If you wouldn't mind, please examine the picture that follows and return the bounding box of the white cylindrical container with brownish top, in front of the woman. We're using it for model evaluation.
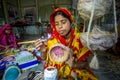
[44,66,57,80]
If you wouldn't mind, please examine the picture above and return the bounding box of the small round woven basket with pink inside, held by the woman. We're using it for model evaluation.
[49,44,69,62]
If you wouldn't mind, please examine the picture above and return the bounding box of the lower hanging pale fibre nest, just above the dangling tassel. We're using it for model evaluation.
[80,26,117,50]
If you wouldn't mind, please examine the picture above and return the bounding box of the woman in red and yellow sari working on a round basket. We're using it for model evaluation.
[35,8,97,80]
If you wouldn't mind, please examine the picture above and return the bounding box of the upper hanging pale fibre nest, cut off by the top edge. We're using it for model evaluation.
[77,0,112,20]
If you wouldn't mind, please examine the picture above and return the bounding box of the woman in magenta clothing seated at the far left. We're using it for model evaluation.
[0,24,18,50]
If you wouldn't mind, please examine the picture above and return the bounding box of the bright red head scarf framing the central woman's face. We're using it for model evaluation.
[50,8,74,45]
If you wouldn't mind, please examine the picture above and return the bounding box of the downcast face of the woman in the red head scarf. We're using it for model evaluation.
[54,15,71,36]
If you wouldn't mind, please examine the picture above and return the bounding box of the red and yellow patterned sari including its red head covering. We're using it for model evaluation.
[44,8,97,80]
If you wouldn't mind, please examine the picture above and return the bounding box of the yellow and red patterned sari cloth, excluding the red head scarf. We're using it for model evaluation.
[44,33,97,80]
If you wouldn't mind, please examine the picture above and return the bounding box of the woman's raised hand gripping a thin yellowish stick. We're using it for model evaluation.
[34,39,47,53]
